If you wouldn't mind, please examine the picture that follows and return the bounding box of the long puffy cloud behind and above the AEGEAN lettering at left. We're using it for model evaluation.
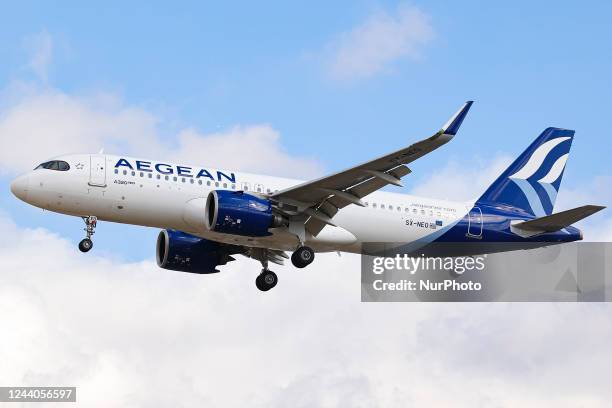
[0,88,322,178]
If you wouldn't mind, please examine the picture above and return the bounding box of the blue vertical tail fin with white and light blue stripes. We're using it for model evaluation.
[477,128,574,217]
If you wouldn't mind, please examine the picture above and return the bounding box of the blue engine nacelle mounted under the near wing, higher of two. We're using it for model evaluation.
[204,190,284,237]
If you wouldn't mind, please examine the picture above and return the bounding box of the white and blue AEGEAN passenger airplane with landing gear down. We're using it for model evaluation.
[11,101,605,291]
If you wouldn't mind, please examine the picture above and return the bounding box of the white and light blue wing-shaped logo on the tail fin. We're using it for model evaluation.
[509,137,571,217]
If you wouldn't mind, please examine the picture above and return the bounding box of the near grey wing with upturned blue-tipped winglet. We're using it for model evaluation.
[270,101,473,235]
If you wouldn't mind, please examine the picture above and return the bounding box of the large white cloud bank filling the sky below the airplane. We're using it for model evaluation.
[0,212,612,407]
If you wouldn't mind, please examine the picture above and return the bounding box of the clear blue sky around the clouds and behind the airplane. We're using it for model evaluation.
[0,1,612,259]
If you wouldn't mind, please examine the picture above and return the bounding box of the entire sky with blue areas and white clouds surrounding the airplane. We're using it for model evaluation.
[0,1,612,407]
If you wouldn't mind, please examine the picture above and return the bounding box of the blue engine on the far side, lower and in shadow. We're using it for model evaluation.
[155,230,240,273]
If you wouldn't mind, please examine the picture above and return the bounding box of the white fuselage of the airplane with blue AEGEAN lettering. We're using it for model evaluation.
[13,154,471,252]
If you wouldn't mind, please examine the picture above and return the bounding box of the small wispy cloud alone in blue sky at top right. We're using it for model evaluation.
[327,5,434,80]
